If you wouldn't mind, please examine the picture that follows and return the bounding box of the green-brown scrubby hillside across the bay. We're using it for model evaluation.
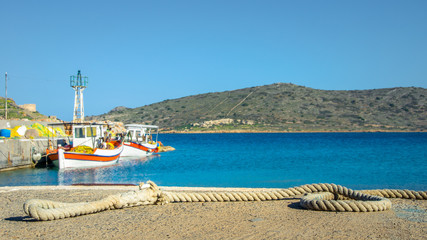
[88,83,427,131]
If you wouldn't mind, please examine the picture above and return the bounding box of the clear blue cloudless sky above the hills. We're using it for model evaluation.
[0,0,427,120]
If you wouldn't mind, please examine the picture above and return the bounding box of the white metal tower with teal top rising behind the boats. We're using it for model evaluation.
[70,70,88,122]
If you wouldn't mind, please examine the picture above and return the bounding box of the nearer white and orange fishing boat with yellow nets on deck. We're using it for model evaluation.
[47,123,123,169]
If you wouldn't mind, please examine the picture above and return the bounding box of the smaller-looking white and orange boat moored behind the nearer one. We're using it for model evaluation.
[120,124,161,158]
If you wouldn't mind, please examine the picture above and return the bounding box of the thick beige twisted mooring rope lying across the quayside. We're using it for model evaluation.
[24,181,427,220]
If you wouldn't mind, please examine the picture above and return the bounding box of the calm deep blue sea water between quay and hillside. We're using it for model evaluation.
[0,133,427,190]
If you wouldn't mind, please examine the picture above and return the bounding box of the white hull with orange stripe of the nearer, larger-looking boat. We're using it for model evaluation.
[49,145,123,169]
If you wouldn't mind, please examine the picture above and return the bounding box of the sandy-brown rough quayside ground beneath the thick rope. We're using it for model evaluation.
[0,186,427,239]
